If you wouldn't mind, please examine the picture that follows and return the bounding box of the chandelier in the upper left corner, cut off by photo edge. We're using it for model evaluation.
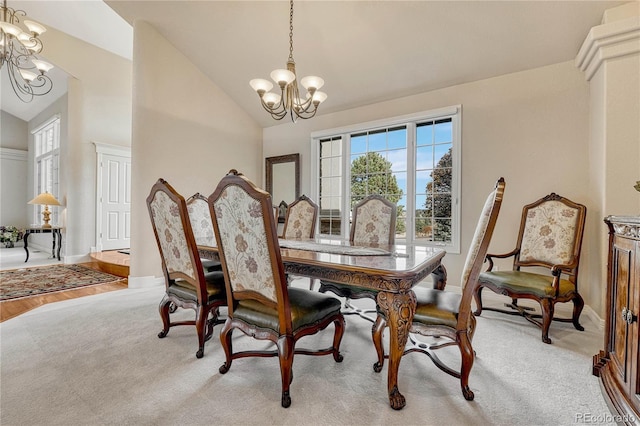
[0,0,53,102]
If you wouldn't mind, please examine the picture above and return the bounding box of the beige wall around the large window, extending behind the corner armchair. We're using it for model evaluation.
[263,61,602,312]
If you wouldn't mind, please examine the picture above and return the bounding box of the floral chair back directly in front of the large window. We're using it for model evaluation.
[350,195,396,246]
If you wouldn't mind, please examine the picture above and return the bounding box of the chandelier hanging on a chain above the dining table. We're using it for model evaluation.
[249,0,327,123]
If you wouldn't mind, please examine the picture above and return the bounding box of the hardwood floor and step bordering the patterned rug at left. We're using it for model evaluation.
[0,252,129,322]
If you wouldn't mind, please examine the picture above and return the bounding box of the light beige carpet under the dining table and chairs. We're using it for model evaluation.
[0,281,613,426]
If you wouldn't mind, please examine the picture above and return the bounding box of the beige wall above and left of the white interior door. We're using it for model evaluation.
[29,28,132,263]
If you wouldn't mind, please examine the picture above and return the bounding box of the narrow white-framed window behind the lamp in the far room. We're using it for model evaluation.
[32,115,60,225]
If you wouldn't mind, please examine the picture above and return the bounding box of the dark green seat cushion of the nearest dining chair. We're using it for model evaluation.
[233,287,342,332]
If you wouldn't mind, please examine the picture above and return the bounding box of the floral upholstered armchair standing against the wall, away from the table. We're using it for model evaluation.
[475,193,587,343]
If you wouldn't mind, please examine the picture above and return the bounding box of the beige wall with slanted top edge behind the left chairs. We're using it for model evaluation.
[129,22,263,286]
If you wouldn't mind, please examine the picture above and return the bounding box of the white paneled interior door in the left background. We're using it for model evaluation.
[97,143,131,251]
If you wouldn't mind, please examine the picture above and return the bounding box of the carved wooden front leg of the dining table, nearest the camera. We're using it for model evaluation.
[377,290,416,410]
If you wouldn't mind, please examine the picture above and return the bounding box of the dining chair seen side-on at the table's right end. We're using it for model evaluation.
[372,178,505,401]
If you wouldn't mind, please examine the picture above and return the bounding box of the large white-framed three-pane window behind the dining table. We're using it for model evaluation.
[311,105,461,253]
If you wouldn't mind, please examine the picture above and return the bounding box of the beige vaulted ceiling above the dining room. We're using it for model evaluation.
[3,0,624,127]
